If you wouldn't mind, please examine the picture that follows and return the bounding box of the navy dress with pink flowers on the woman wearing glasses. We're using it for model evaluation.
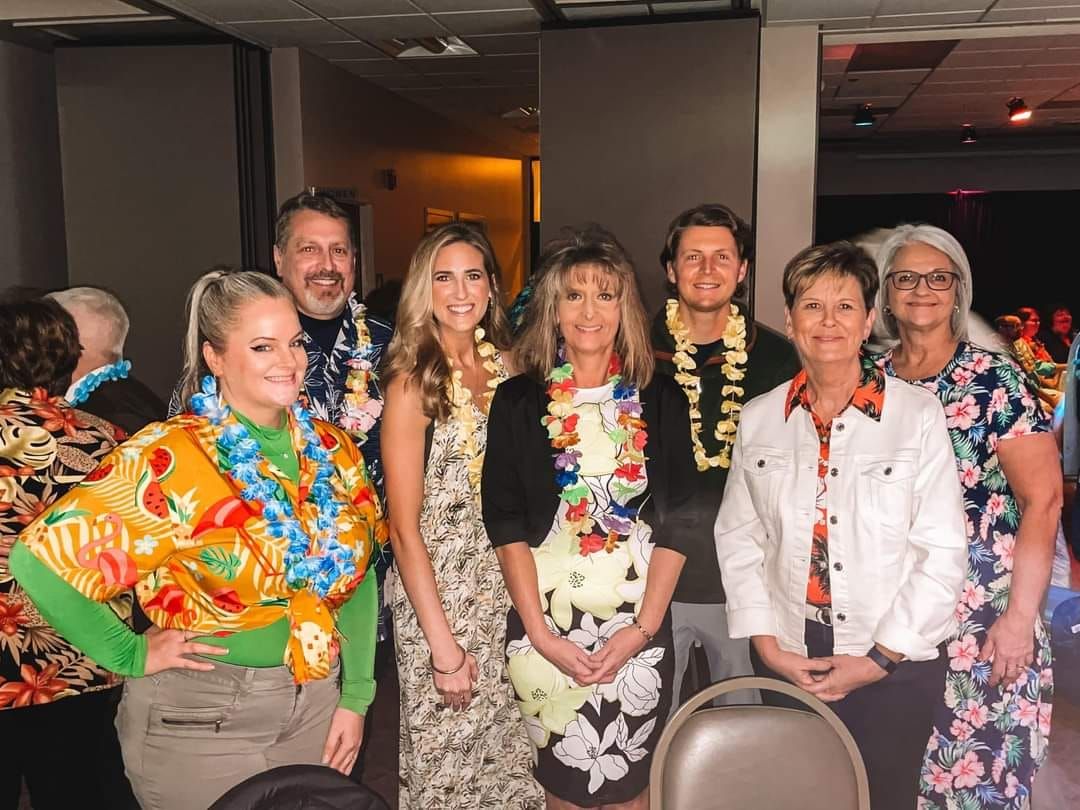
[881,341,1054,810]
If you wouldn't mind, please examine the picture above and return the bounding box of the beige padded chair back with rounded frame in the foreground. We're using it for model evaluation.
[649,677,870,810]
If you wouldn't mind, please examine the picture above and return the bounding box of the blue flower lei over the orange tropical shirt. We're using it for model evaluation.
[191,377,356,599]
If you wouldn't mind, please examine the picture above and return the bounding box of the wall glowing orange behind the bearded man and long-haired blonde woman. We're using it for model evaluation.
[293,52,527,302]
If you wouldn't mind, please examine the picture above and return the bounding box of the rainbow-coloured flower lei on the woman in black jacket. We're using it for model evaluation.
[540,354,648,556]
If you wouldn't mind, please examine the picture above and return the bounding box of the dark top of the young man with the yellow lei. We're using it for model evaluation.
[652,309,799,604]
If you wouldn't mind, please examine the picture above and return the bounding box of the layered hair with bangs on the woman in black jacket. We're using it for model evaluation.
[515,225,656,388]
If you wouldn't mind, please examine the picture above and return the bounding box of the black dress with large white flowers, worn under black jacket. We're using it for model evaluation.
[507,384,675,807]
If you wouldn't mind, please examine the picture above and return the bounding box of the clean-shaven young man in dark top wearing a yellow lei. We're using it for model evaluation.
[650,204,799,712]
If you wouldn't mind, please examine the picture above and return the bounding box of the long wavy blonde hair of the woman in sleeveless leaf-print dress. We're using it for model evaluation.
[382,222,510,421]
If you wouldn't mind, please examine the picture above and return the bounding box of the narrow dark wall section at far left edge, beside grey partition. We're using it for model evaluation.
[0,42,67,289]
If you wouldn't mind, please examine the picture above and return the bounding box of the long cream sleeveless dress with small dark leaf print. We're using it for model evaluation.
[392,382,543,810]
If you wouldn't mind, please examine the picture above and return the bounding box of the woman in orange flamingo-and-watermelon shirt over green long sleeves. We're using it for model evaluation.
[11,271,386,810]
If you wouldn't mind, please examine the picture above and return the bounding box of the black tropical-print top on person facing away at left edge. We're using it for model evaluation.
[0,389,131,708]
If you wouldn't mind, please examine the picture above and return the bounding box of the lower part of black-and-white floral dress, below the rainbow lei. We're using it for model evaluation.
[507,524,675,807]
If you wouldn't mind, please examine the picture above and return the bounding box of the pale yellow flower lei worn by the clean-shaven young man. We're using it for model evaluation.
[664,298,746,472]
